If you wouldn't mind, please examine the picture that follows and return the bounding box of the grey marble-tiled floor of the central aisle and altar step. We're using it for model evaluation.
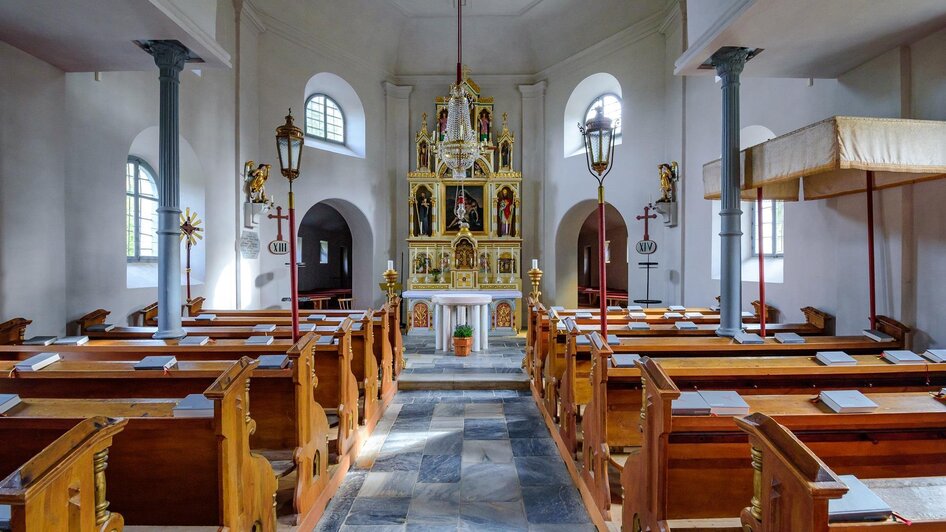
[316,338,594,532]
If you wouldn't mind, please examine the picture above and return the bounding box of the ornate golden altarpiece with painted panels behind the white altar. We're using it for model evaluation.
[404,77,522,334]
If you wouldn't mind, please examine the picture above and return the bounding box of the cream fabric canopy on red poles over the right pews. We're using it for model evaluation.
[703,116,946,200]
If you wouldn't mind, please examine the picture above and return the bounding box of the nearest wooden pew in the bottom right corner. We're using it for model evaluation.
[734,413,946,532]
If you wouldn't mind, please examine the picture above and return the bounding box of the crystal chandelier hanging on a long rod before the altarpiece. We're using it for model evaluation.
[438,0,480,179]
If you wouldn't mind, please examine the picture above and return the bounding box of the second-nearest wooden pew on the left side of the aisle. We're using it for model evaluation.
[4,358,276,531]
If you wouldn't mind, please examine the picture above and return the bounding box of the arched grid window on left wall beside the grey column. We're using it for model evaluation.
[125,157,158,262]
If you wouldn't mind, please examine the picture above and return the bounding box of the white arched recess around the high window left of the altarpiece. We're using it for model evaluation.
[299,72,365,159]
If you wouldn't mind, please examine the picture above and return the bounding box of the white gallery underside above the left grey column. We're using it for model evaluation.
[0,0,230,72]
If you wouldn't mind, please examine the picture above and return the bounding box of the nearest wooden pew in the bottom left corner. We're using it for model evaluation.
[0,416,127,532]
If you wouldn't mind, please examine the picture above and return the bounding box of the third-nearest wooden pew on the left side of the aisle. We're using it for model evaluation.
[0,334,340,526]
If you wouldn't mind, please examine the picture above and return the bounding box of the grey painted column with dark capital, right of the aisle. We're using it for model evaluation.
[711,48,749,336]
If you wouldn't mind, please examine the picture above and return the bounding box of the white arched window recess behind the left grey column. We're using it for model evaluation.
[121,126,207,288]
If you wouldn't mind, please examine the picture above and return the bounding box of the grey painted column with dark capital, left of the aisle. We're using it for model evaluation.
[149,41,190,338]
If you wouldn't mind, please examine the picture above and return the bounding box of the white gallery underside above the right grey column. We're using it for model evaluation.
[676,0,946,78]
